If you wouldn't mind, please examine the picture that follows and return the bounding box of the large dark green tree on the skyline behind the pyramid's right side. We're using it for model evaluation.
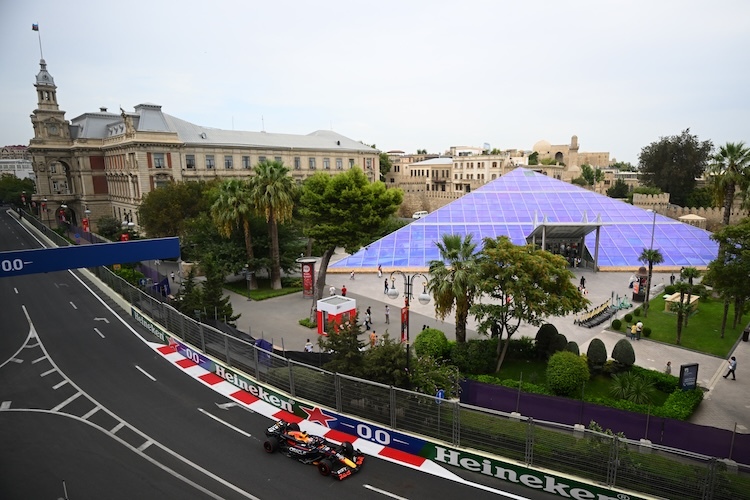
[638,129,713,206]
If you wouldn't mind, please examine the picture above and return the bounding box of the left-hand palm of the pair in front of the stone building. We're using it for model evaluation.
[211,179,258,290]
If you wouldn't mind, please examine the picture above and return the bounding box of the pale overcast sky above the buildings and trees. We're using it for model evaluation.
[0,0,750,163]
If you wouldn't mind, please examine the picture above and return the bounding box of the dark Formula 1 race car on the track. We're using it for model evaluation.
[263,420,365,481]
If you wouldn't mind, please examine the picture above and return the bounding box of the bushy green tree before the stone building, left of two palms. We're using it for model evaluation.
[138,181,215,238]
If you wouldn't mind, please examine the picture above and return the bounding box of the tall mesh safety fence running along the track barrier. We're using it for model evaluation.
[19,212,750,500]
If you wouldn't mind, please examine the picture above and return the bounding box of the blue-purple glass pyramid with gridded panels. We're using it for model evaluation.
[331,168,718,271]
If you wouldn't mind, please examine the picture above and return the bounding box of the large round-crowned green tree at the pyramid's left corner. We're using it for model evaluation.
[300,168,403,304]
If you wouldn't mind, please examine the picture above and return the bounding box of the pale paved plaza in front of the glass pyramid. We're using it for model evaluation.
[201,255,750,433]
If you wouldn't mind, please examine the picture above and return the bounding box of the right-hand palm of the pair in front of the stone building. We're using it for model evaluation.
[250,160,295,290]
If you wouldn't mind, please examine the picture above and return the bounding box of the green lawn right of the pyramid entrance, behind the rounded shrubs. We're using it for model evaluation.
[620,295,747,358]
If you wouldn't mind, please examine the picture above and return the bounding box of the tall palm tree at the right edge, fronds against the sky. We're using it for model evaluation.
[708,142,750,226]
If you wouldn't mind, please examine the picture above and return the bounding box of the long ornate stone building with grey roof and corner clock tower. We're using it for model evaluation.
[28,59,380,230]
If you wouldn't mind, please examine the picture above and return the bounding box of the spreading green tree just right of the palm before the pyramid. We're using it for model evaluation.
[471,236,589,371]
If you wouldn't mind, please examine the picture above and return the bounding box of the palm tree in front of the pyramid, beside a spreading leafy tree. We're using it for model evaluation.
[427,234,477,342]
